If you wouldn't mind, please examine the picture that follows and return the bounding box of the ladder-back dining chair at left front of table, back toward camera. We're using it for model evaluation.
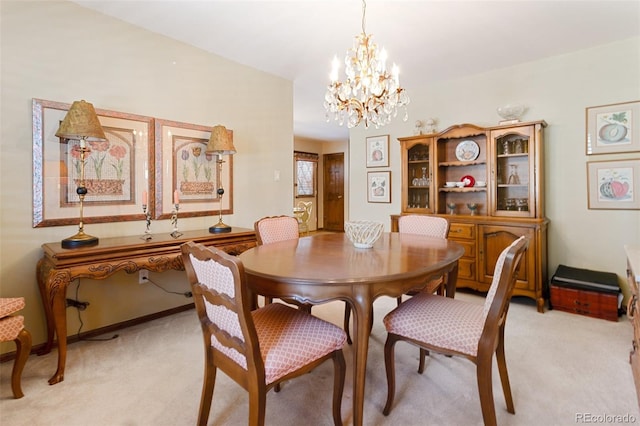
[181,242,347,426]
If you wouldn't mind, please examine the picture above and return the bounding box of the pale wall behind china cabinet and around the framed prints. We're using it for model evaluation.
[349,38,640,300]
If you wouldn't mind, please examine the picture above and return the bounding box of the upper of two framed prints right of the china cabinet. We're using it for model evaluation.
[586,101,640,155]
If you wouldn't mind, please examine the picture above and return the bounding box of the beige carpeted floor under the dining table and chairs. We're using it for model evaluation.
[0,292,640,426]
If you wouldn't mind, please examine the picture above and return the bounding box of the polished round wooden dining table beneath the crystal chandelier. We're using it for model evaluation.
[239,232,464,426]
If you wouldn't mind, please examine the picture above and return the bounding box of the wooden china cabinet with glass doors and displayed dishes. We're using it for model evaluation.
[391,121,548,312]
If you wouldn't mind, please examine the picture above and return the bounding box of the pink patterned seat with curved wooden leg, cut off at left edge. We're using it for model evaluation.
[0,297,31,399]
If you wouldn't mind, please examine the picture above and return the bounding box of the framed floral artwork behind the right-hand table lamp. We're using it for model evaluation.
[155,119,233,219]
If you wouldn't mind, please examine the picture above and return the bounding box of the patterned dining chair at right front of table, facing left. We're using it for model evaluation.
[382,236,529,426]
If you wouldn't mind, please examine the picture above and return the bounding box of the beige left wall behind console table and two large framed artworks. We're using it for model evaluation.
[0,0,293,352]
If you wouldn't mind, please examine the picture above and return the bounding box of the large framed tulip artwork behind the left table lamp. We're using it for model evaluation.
[32,99,154,228]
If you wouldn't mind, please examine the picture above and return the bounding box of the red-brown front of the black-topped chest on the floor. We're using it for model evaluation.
[550,284,618,321]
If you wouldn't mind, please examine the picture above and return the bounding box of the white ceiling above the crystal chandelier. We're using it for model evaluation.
[74,0,640,141]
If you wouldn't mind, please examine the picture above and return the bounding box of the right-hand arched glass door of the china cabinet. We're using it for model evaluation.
[491,126,536,217]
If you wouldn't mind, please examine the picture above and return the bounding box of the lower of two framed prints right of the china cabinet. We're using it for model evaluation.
[587,159,640,210]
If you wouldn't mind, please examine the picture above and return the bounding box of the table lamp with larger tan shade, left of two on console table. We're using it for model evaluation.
[56,100,107,248]
